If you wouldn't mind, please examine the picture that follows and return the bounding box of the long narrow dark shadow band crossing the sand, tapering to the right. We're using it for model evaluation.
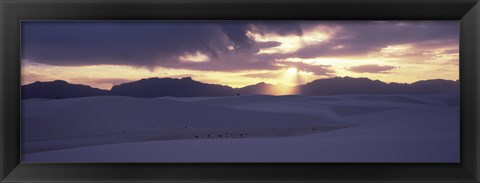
[22,125,351,154]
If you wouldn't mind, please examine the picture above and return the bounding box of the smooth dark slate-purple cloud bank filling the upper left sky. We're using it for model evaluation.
[22,22,228,66]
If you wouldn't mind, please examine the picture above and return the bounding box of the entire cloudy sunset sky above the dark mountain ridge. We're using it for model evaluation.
[21,21,459,89]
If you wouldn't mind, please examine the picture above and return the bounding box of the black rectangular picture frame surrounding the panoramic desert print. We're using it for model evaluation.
[0,0,480,182]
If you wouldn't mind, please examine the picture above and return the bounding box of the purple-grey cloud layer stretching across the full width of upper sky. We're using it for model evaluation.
[22,21,459,71]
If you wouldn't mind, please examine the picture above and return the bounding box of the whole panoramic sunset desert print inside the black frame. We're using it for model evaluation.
[21,21,460,163]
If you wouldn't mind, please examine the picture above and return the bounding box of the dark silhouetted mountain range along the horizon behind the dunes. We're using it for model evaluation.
[22,77,460,99]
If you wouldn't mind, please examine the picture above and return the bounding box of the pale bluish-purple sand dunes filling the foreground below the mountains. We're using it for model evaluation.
[22,94,459,162]
